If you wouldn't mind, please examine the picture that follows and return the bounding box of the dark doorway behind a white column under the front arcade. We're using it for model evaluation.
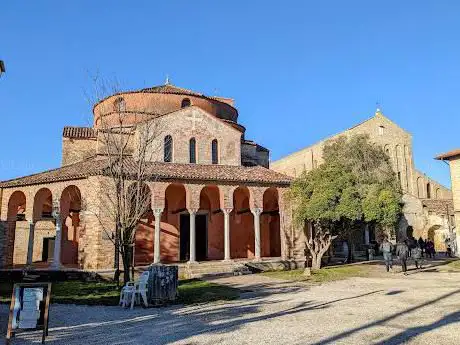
[179,214,208,261]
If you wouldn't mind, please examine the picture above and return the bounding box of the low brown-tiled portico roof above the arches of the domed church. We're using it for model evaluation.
[0,157,292,188]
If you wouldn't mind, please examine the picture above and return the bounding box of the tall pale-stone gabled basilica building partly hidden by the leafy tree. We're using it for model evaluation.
[270,109,455,251]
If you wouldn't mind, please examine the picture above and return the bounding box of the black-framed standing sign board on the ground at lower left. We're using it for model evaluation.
[6,283,51,345]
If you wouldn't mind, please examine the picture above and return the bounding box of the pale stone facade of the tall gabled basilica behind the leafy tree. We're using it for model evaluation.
[270,110,452,250]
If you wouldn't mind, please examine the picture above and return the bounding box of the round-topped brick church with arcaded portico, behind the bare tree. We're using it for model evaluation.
[0,82,304,270]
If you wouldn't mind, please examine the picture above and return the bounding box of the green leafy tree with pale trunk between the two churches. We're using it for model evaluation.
[290,135,402,269]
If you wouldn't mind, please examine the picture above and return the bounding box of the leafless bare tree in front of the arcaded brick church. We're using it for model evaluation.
[85,78,161,283]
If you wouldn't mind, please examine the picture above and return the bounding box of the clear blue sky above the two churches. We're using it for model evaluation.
[0,0,460,185]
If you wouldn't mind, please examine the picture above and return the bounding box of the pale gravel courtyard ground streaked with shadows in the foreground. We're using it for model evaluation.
[0,269,460,345]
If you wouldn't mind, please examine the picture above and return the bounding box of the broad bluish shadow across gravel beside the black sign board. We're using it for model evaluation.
[0,290,382,345]
